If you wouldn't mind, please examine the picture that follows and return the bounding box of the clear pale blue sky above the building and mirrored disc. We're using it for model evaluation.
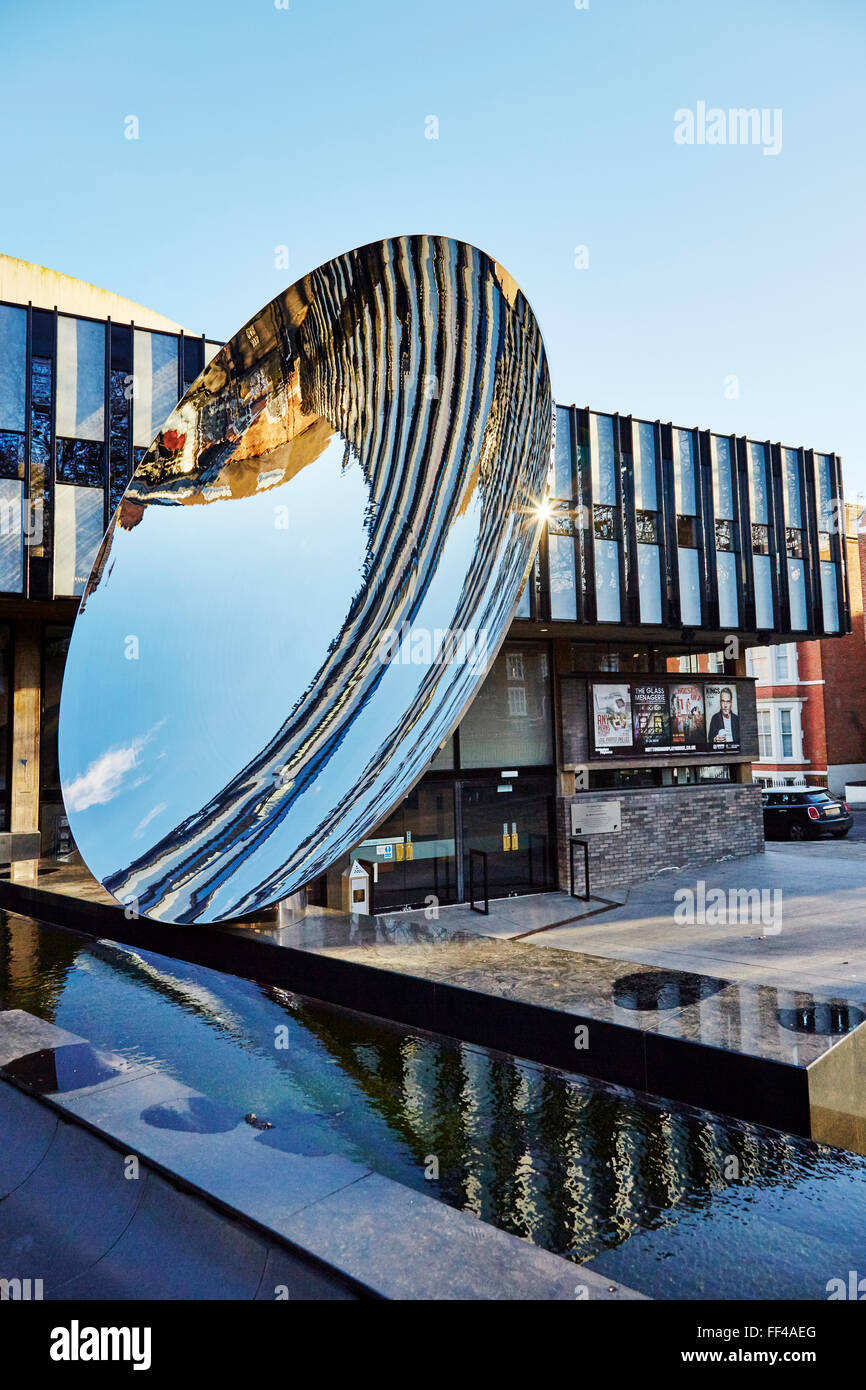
[0,0,866,496]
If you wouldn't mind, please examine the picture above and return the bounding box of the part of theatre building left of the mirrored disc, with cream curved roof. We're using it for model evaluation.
[0,256,218,855]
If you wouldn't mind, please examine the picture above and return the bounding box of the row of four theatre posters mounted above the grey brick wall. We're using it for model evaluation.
[589,676,741,758]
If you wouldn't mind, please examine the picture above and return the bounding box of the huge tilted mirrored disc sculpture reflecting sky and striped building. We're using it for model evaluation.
[60,236,552,923]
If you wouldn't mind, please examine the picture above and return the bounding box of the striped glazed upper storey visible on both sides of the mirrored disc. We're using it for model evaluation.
[0,283,849,646]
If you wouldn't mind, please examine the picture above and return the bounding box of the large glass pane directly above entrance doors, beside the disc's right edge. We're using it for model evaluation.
[460,642,553,767]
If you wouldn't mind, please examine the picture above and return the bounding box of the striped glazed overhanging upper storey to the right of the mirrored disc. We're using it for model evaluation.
[518,406,851,645]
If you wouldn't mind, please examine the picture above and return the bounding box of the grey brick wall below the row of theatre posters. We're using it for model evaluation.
[556,784,763,892]
